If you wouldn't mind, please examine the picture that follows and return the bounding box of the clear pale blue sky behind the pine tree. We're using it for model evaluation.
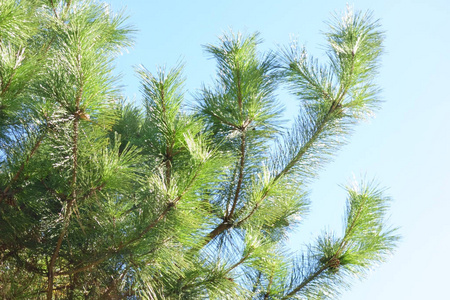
[105,0,450,300]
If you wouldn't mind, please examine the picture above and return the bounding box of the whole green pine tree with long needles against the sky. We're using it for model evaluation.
[0,0,398,299]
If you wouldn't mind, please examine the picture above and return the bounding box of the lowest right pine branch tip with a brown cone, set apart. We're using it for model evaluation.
[282,179,398,299]
